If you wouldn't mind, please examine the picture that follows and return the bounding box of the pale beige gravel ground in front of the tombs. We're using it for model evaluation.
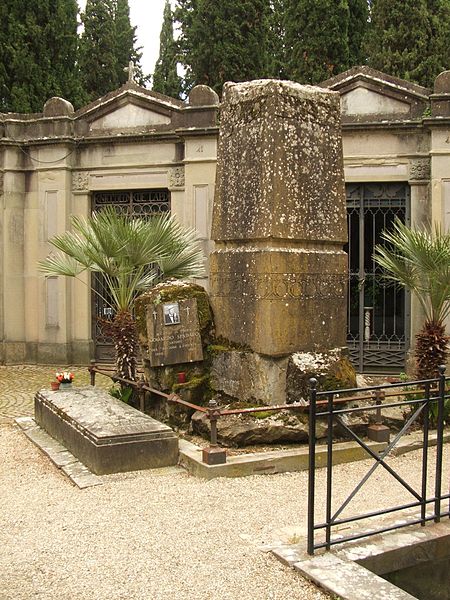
[0,425,449,600]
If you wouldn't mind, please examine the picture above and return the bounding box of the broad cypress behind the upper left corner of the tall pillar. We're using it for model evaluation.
[184,0,269,94]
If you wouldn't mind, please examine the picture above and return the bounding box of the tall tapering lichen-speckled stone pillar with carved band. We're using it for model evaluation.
[210,80,354,403]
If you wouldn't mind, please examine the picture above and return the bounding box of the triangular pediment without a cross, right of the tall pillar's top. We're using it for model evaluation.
[321,66,431,121]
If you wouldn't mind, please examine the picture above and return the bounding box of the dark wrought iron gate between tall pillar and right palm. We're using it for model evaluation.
[346,183,410,373]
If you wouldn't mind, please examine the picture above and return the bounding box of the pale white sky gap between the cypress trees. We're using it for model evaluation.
[78,0,174,75]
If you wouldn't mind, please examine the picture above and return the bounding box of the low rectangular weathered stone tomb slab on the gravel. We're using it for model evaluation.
[34,386,178,475]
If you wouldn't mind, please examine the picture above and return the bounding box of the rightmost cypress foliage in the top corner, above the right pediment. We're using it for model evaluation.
[366,0,450,86]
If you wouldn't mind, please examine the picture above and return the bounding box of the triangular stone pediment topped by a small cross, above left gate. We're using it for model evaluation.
[77,83,184,134]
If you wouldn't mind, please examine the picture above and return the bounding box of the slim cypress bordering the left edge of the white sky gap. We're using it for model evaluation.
[115,0,147,85]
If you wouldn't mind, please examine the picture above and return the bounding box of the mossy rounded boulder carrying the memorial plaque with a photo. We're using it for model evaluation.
[136,280,213,418]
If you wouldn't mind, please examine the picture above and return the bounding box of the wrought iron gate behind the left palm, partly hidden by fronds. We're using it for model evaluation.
[92,190,170,362]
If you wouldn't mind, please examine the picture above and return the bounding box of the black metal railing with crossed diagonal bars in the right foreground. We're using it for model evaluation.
[307,367,450,554]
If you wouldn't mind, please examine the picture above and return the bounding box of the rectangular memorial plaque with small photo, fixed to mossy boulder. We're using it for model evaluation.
[147,298,203,367]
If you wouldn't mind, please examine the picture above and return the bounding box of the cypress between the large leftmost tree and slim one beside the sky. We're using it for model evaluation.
[80,0,119,100]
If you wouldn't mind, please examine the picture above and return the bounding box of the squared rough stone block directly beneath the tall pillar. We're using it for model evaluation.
[211,350,288,404]
